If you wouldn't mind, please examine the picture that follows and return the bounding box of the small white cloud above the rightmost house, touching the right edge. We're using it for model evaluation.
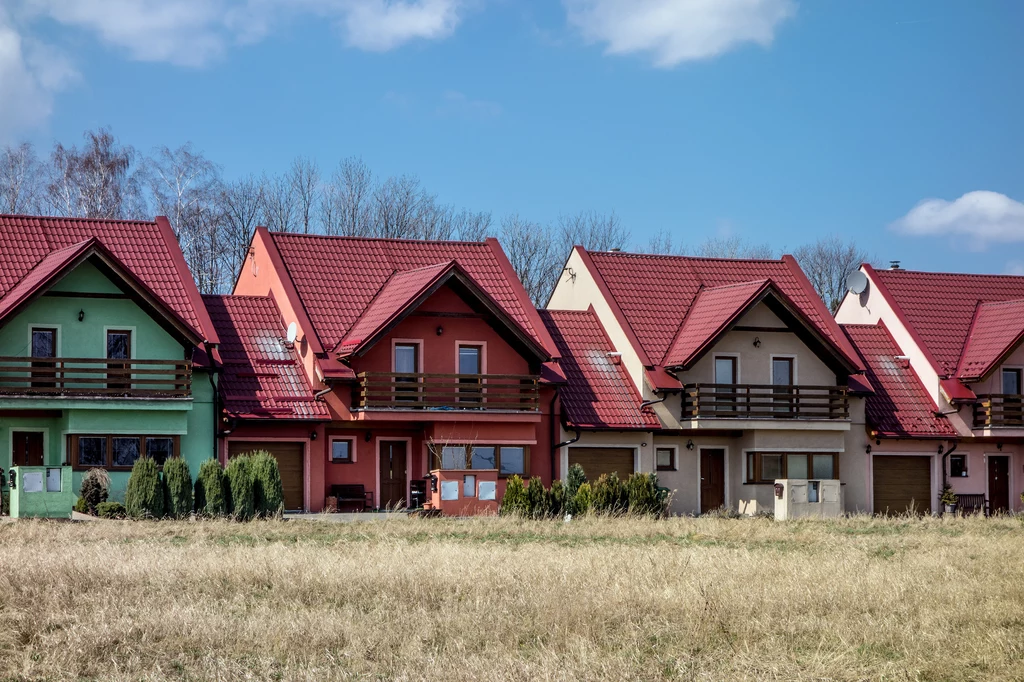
[892,190,1024,250]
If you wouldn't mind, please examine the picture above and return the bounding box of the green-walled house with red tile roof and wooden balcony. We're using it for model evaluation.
[0,216,218,501]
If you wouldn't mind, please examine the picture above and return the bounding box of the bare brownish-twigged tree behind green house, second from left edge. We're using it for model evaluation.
[47,128,142,218]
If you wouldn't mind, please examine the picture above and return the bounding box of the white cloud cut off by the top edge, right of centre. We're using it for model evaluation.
[563,0,796,68]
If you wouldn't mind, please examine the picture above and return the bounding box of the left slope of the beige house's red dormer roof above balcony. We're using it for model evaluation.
[660,280,770,367]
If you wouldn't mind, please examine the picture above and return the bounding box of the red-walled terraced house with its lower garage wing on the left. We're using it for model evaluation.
[220,228,563,513]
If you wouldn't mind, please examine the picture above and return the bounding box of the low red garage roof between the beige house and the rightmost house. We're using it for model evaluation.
[843,323,956,438]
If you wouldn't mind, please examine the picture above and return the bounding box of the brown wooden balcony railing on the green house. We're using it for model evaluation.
[0,357,191,397]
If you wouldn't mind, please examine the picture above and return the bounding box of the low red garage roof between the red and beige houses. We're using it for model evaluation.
[540,310,660,430]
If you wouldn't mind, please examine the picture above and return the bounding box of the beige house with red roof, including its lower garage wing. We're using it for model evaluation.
[545,247,866,514]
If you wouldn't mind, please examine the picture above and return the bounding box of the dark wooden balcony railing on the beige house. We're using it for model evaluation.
[683,384,850,420]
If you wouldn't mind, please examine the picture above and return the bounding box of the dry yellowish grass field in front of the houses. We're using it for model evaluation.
[0,518,1024,680]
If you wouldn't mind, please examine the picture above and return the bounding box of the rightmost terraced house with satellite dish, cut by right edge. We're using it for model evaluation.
[836,265,1024,513]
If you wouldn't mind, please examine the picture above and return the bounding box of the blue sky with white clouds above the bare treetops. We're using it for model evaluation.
[0,0,1024,273]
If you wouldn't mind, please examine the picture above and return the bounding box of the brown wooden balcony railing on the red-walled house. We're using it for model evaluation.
[353,372,540,412]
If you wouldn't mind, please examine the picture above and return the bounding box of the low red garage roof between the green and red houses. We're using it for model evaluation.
[203,296,331,420]
